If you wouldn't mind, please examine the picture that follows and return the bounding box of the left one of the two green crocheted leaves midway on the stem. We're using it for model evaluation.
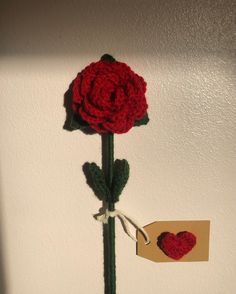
[84,162,111,201]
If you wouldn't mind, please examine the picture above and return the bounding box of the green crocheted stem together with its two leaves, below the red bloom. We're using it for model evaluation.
[84,133,129,294]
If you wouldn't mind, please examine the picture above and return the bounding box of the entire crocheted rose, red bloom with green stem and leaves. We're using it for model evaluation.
[68,54,149,294]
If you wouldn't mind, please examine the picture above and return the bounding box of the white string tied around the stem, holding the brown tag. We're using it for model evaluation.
[95,209,150,245]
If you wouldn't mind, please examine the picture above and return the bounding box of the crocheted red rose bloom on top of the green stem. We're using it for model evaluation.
[72,55,149,134]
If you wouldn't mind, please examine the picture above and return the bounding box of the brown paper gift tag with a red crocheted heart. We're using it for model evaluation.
[136,220,210,262]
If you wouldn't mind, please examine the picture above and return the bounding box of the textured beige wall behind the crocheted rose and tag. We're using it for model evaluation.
[0,0,236,294]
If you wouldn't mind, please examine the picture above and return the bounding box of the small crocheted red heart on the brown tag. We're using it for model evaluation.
[157,231,197,260]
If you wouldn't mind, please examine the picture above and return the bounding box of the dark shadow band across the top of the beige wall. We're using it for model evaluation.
[0,0,236,57]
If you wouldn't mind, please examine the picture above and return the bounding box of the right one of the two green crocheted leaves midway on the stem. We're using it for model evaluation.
[112,159,129,202]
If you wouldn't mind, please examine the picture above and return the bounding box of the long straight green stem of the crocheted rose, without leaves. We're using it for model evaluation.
[102,133,116,294]
